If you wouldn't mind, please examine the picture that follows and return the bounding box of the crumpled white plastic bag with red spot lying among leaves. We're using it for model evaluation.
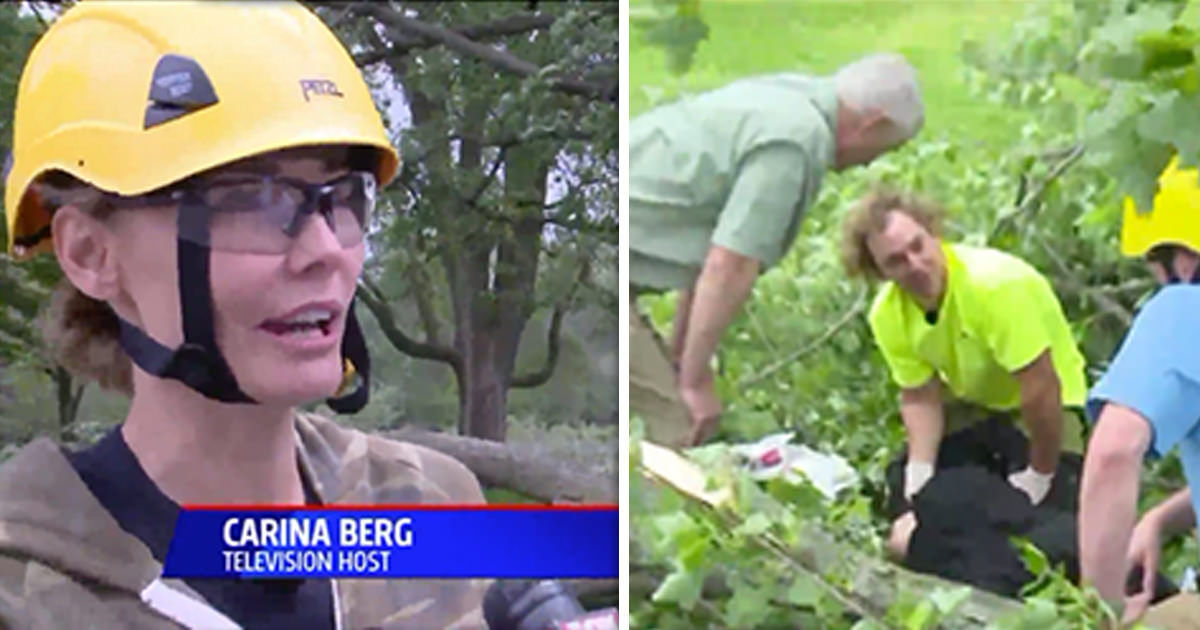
[732,433,858,499]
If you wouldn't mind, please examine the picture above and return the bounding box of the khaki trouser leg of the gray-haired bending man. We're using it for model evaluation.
[629,300,691,449]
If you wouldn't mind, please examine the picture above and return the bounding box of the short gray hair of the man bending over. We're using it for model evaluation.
[834,53,925,140]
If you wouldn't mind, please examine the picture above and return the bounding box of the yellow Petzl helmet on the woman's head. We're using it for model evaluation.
[5,0,400,259]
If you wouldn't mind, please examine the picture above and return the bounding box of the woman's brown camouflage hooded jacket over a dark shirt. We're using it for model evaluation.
[0,414,490,630]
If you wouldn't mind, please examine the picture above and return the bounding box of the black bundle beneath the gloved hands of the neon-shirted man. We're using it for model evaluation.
[888,420,1177,601]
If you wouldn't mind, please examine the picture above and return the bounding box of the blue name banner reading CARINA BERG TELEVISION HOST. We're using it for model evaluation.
[163,505,619,580]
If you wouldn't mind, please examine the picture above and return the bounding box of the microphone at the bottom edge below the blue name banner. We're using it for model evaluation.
[484,580,618,630]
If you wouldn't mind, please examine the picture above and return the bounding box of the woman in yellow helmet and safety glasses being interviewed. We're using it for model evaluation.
[0,1,486,630]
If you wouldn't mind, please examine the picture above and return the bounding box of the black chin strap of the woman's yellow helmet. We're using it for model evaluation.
[118,196,371,414]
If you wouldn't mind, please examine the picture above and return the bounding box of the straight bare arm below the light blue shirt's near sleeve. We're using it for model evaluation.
[1079,403,1151,605]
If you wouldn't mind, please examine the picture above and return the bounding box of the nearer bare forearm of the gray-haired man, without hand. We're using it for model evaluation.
[679,245,758,389]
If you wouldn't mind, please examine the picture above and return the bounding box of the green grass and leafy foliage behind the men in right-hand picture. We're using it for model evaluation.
[630,0,1200,628]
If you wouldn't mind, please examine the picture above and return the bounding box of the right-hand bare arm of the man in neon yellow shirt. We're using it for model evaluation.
[1013,349,1062,474]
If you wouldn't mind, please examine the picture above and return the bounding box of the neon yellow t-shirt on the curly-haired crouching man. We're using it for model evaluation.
[868,244,1087,450]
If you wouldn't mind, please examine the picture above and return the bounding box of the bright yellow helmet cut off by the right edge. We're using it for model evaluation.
[1121,156,1200,257]
